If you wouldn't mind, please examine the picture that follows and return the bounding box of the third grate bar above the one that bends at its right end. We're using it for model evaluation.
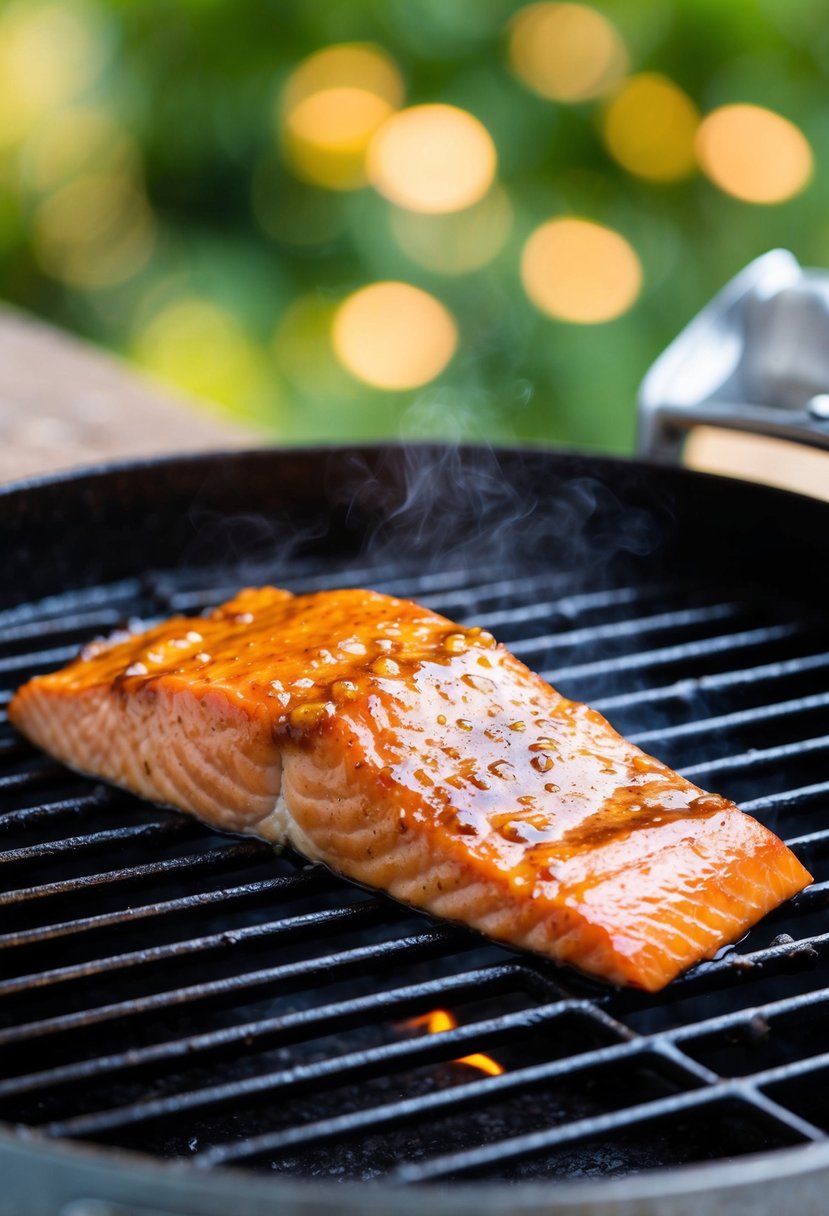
[0,867,331,950]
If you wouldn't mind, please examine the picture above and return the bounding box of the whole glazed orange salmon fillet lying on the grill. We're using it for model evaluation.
[9,587,811,991]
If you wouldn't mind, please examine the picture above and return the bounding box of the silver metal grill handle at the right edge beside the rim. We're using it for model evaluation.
[638,249,829,463]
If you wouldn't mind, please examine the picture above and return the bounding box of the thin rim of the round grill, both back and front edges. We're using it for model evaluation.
[0,443,829,1216]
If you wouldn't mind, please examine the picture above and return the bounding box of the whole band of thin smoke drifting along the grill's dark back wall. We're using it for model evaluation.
[162,445,670,637]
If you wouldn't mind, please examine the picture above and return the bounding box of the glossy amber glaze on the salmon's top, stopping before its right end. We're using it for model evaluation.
[68,587,731,895]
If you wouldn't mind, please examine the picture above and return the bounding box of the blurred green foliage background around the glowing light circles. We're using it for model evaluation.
[0,0,829,451]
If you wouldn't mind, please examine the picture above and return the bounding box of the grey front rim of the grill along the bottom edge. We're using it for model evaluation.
[8,1124,829,1216]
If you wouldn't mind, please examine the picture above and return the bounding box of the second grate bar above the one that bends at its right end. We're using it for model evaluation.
[0,899,389,997]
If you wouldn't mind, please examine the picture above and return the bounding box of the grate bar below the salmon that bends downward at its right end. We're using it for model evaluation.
[0,962,534,1098]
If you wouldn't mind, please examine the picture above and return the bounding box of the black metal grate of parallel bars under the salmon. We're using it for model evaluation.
[0,561,829,1183]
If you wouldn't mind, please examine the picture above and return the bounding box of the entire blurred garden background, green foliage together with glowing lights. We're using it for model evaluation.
[0,0,829,451]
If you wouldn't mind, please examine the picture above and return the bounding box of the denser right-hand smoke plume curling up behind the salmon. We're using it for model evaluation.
[329,444,662,585]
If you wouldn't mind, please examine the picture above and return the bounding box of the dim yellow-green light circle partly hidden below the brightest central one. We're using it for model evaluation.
[390,184,513,275]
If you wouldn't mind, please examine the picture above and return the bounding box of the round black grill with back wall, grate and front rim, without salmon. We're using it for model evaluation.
[0,447,829,1212]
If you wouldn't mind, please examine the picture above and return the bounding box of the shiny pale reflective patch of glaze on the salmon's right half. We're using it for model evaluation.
[349,641,733,901]
